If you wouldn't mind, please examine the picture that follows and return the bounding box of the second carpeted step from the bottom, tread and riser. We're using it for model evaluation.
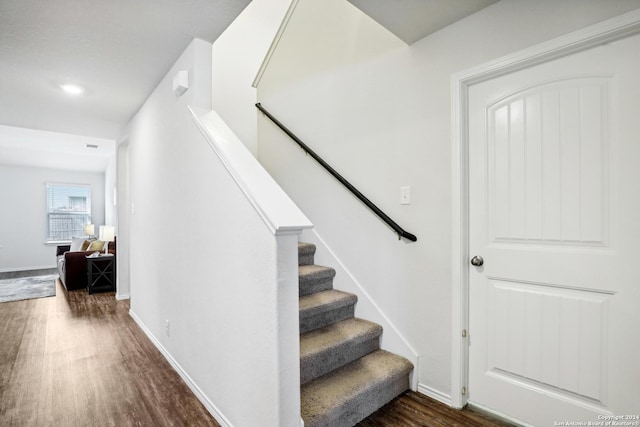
[300,318,382,384]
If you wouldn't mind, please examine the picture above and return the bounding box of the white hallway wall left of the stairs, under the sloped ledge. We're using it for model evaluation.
[127,40,300,427]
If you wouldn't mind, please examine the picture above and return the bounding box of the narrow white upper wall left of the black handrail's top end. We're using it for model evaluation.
[212,0,291,156]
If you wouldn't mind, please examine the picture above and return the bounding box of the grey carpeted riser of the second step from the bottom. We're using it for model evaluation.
[300,336,380,384]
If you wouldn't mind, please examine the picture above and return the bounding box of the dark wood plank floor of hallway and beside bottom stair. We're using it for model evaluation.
[0,276,507,427]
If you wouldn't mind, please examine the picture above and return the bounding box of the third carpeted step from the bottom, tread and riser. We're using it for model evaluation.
[298,289,358,334]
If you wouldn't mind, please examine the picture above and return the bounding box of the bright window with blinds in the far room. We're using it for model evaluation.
[47,184,91,242]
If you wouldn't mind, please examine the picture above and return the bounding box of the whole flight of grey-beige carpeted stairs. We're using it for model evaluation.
[298,243,413,427]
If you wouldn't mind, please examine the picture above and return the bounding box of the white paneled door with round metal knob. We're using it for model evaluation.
[469,32,640,426]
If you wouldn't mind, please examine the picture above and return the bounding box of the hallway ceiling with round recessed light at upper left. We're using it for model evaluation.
[0,0,250,174]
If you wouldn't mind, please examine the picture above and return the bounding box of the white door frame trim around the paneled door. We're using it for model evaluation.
[451,9,640,408]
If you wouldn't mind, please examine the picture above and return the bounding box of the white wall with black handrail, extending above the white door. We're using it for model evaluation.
[258,0,640,401]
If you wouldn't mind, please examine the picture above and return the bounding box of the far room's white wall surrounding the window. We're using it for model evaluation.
[0,165,105,271]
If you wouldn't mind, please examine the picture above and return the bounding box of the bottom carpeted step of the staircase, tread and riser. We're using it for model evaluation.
[301,350,413,427]
